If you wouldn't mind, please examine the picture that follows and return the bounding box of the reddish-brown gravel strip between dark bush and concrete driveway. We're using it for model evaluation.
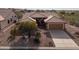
[39,29,55,47]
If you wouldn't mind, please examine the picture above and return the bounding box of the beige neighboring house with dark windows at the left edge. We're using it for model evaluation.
[0,9,18,30]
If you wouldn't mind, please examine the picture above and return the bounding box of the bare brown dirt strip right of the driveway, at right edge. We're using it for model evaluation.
[66,24,79,46]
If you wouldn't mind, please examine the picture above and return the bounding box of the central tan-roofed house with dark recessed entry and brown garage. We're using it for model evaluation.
[23,12,66,30]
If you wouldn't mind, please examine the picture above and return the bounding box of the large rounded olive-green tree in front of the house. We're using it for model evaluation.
[19,21,37,38]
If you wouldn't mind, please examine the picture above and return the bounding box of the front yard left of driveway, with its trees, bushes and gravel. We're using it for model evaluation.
[7,22,55,48]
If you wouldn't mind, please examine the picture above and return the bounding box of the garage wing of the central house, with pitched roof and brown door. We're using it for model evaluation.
[44,16,66,30]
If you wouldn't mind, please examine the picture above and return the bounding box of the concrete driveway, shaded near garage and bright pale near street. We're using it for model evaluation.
[50,30,78,48]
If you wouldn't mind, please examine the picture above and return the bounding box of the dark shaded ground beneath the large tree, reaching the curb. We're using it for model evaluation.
[10,37,39,50]
